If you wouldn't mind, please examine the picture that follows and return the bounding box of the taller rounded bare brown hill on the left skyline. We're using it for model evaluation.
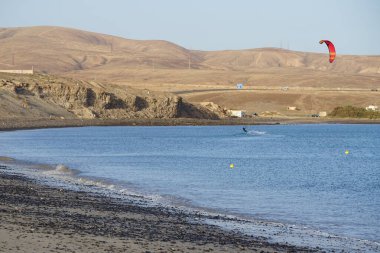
[0,27,197,73]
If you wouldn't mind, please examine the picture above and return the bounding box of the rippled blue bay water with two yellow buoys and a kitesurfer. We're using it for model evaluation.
[0,124,380,251]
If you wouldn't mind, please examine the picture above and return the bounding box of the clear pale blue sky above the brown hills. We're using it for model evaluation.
[0,0,380,55]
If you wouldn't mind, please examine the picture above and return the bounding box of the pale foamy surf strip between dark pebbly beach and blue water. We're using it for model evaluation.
[0,158,380,252]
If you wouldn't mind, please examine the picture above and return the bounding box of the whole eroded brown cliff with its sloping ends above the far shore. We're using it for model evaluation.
[0,75,226,119]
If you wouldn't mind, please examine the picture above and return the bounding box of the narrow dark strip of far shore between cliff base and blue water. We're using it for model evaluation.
[0,117,380,131]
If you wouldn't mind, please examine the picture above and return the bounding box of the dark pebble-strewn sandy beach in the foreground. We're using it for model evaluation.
[0,163,315,252]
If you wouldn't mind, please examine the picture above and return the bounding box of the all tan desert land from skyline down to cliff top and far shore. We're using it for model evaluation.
[0,27,380,115]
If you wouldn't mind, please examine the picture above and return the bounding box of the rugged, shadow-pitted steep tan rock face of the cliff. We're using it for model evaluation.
[35,84,182,118]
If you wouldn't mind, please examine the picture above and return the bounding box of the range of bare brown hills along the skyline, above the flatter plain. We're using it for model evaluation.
[0,26,380,74]
